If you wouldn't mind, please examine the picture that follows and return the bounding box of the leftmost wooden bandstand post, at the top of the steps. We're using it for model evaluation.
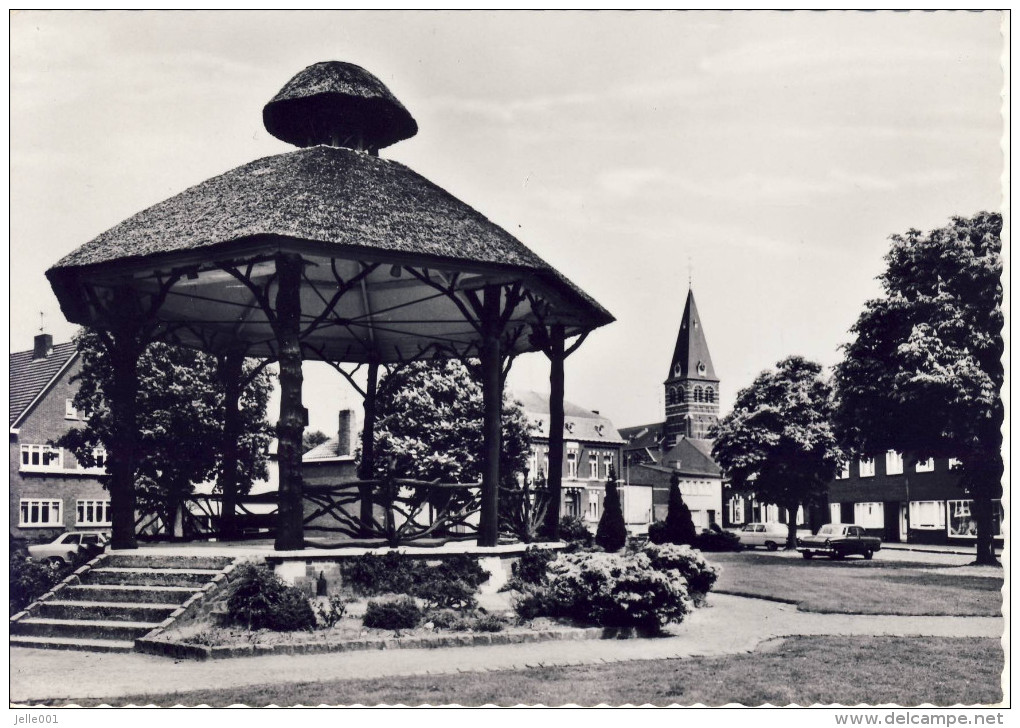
[106,329,144,549]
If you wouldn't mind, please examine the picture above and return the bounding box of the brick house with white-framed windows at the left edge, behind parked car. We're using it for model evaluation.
[8,333,110,540]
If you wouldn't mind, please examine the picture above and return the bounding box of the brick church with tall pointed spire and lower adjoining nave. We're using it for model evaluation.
[620,290,723,528]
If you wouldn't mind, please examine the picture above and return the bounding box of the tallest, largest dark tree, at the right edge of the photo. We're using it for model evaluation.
[834,212,1004,564]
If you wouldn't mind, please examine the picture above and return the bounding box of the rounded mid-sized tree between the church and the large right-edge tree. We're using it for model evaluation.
[712,356,843,549]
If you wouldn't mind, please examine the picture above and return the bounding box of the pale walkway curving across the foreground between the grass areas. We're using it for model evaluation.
[10,594,1004,705]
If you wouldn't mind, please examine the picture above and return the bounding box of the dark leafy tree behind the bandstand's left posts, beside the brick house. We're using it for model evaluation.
[57,329,271,530]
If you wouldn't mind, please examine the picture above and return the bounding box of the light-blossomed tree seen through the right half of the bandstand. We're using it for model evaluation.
[374,359,531,487]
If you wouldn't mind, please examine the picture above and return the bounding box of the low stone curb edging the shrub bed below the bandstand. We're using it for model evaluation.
[135,627,605,660]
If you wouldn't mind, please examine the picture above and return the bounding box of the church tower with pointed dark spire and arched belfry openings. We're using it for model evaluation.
[665,290,719,448]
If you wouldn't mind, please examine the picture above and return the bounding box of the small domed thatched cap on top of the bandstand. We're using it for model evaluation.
[262,61,418,150]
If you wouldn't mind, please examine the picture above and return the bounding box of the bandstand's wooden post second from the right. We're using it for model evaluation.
[478,285,503,547]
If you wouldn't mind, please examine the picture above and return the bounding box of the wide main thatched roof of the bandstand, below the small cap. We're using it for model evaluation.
[47,147,613,361]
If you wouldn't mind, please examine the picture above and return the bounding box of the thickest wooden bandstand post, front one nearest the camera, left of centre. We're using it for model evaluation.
[275,253,305,551]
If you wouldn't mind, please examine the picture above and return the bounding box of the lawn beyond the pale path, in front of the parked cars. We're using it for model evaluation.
[708,552,1003,617]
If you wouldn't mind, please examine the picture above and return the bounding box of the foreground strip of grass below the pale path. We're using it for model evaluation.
[47,637,1004,707]
